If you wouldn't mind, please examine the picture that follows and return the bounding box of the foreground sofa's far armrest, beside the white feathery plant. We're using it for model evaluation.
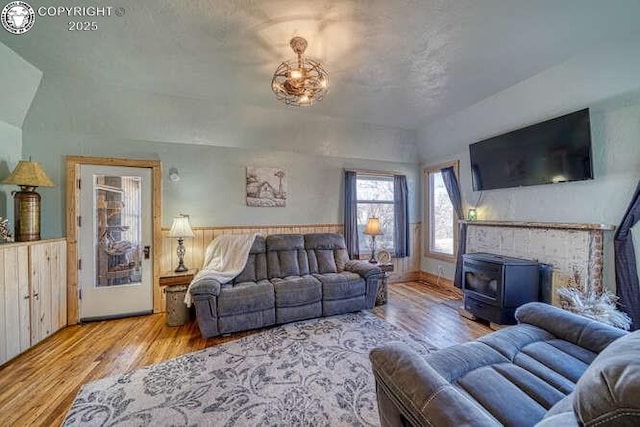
[516,302,627,353]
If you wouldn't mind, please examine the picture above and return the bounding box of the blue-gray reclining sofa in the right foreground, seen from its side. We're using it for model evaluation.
[370,303,640,427]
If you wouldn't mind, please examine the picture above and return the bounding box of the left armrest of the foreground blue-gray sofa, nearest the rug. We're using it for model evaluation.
[369,343,500,426]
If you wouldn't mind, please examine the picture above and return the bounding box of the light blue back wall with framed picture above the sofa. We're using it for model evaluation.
[23,75,419,237]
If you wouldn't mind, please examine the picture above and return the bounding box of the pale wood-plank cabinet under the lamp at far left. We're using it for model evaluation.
[0,239,67,364]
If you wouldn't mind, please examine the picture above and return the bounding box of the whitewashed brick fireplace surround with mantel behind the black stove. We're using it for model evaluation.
[463,221,615,305]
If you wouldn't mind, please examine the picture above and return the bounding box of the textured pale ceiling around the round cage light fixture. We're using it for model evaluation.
[0,0,640,129]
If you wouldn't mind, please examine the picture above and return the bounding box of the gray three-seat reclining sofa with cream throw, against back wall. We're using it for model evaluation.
[191,233,381,338]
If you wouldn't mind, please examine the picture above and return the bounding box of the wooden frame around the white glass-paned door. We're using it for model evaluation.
[66,156,163,325]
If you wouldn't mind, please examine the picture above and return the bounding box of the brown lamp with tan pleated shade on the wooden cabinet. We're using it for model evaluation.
[2,159,55,242]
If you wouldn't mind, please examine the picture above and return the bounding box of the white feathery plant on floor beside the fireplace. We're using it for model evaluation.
[558,272,631,330]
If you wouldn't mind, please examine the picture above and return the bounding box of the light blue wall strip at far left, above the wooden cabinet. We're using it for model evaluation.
[0,43,42,224]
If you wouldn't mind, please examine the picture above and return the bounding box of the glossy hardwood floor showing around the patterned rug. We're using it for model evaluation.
[0,282,491,426]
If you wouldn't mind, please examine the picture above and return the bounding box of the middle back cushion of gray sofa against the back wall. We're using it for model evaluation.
[266,234,309,279]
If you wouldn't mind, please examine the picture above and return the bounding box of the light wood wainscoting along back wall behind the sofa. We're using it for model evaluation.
[160,223,420,309]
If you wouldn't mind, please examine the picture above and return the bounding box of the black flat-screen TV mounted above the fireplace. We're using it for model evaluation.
[469,108,593,191]
